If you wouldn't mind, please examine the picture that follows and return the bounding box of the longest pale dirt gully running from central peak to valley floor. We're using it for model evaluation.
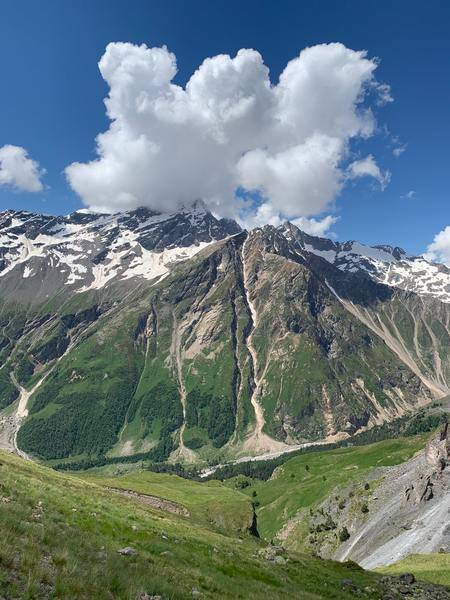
[242,237,288,452]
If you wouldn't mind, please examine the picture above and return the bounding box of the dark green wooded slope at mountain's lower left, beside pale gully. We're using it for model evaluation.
[18,310,142,459]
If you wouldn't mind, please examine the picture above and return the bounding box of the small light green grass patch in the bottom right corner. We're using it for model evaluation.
[377,554,450,586]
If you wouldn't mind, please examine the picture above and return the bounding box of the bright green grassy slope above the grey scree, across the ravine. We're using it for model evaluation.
[234,434,430,547]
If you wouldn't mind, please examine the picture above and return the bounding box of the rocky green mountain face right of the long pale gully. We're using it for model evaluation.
[243,254,436,439]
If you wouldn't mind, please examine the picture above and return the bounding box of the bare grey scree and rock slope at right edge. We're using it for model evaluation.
[324,425,450,569]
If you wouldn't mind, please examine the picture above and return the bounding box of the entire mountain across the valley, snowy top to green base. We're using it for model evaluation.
[0,205,450,462]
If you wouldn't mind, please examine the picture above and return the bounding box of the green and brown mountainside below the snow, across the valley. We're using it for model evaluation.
[0,233,450,468]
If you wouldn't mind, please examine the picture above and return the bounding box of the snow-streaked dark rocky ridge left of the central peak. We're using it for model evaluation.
[0,206,240,296]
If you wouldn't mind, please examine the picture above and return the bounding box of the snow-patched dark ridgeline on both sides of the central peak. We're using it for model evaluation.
[0,201,450,302]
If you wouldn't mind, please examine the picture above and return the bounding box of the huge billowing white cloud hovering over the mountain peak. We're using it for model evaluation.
[66,43,390,223]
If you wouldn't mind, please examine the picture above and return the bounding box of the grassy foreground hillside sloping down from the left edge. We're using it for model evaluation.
[0,452,390,600]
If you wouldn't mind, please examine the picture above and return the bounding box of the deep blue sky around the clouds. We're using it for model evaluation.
[0,0,450,253]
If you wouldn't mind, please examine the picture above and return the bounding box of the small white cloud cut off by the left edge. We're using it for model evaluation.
[0,144,45,192]
